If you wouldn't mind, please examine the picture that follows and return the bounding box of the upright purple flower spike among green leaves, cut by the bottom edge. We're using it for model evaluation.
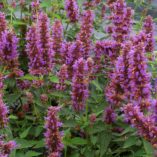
[45,106,63,157]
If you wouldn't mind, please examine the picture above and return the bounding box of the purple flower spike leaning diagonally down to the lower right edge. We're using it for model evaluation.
[123,104,157,146]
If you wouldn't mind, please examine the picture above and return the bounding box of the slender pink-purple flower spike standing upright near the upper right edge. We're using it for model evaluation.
[143,16,155,52]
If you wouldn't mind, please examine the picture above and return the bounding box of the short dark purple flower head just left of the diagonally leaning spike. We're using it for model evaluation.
[103,106,117,124]
